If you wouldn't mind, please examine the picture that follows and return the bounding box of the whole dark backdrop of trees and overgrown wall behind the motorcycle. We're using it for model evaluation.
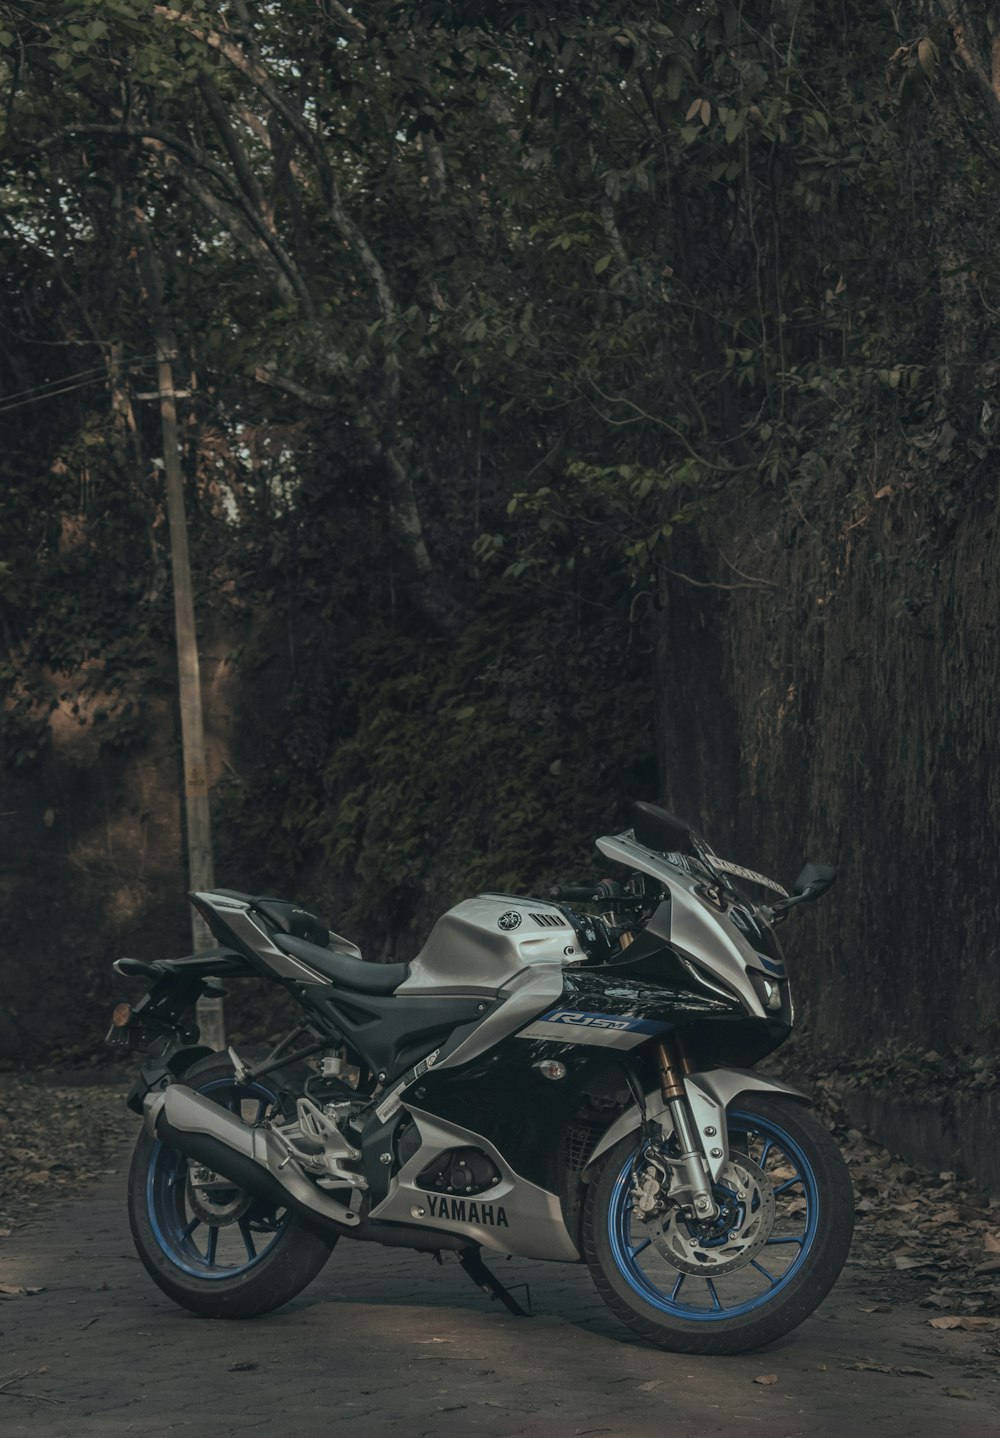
[0,0,1000,1063]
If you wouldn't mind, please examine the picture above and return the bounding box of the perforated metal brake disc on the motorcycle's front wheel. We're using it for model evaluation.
[649,1153,774,1278]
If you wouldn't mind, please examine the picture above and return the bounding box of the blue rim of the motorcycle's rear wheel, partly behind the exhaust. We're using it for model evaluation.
[145,1079,289,1281]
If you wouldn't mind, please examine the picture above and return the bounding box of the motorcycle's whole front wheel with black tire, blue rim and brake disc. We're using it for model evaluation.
[583,1094,853,1353]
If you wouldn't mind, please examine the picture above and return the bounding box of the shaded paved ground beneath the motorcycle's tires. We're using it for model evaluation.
[0,1104,1000,1438]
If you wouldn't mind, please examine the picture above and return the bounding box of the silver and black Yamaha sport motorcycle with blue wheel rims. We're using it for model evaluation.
[108,802,853,1355]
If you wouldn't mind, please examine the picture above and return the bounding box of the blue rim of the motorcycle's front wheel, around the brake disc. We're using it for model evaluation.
[607,1112,820,1323]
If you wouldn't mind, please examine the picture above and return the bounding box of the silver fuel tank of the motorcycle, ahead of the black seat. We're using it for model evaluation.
[396,893,587,994]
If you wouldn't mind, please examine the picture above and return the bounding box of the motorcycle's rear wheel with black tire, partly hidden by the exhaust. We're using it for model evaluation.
[128,1054,337,1319]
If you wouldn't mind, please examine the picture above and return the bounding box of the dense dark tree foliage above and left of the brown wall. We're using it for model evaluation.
[0,0,997,977]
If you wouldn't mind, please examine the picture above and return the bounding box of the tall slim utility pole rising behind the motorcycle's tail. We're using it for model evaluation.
[135,227,226,1048]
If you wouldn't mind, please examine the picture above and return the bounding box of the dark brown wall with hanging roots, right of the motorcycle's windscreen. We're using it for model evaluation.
[660,454,1000,1063]
